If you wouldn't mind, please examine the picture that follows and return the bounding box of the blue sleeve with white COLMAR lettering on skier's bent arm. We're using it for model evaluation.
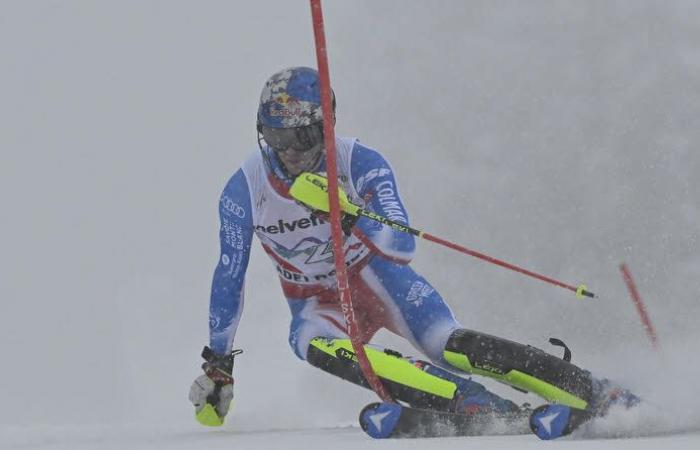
[350,142,416,264]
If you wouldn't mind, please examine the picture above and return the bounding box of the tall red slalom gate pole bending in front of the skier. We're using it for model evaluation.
[310,0,393,402]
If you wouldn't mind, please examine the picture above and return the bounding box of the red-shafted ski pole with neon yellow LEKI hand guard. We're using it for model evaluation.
[289,172,596,298]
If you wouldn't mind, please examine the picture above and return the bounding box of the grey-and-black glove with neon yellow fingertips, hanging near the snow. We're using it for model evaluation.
[189,347,243,426]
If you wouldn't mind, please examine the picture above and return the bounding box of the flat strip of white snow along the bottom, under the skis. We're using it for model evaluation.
[0,425,700,450]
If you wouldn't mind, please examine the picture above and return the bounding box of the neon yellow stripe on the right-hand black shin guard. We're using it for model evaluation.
[443,350,588,409]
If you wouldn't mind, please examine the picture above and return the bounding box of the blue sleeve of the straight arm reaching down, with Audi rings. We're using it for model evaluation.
[209,170,253,354]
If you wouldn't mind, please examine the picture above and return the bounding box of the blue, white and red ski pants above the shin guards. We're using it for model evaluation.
[287,256,462,365]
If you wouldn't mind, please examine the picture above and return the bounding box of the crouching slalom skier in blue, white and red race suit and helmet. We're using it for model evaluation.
[190,67,636,434]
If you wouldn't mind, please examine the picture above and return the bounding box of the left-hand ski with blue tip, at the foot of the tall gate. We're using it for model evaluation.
[360,402,530,439]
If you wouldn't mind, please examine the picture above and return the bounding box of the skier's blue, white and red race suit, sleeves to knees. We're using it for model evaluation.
[209,138,461,362]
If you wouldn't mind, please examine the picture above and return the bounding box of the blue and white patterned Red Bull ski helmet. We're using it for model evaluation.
[257,67,335,131]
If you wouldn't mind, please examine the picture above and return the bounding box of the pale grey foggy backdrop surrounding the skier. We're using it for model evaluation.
[0,0,700,438]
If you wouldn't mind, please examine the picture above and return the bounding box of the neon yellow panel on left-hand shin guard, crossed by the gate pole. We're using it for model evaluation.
[310,338,457,399]
